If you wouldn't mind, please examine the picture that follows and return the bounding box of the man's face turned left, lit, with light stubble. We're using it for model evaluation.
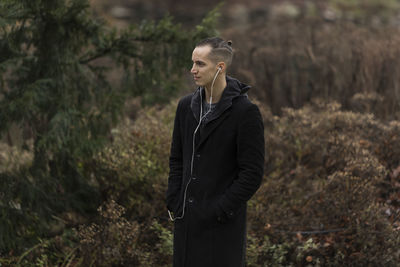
[190,45,217,88]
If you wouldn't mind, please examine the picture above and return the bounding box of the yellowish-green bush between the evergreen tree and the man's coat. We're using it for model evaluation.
[83,101,175,220]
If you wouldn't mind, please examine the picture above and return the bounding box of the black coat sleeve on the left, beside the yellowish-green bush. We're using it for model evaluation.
[166,102,183,212]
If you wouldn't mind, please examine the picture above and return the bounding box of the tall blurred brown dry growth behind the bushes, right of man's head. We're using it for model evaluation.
[230,18,400,119]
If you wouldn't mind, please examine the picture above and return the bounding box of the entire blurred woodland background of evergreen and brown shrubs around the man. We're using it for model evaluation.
[0,0,400,266]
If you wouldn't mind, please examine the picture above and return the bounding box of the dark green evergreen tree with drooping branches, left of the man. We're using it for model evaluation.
[0,0,218,251]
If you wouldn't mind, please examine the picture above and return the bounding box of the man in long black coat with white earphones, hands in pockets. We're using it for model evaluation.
[167,37,264,267]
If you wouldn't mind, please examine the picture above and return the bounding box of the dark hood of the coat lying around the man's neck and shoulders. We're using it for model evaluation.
[190,76,251,124]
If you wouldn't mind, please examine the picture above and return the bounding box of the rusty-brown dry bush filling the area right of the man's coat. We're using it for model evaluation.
[249,97,400,266]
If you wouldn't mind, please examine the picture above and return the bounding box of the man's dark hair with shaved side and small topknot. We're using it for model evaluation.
[196,37,233,66]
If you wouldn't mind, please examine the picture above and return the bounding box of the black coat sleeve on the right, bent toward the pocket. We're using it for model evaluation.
[217,104,265,219]
